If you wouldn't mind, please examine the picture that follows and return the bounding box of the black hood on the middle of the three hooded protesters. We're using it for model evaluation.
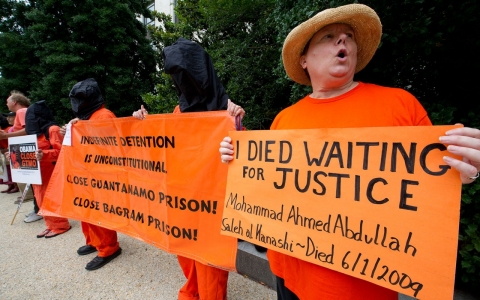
[68,78,105,120]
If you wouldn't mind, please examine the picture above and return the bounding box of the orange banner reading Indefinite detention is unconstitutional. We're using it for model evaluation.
[42,112,237,270]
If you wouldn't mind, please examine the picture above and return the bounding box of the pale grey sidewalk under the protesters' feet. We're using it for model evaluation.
[0,191,276,300]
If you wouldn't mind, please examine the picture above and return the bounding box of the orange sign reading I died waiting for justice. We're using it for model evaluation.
[222,126,461,299]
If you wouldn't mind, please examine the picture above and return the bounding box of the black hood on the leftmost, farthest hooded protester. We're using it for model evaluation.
[25,100,57,140]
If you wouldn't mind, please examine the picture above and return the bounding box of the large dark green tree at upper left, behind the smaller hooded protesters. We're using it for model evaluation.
[2,0,156,121]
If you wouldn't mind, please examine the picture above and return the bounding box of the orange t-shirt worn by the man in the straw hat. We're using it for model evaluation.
[267,82,432,300]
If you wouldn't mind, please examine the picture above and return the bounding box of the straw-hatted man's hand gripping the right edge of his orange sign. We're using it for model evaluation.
[440,127,480,183]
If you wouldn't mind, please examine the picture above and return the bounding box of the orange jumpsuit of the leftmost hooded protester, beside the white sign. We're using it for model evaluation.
[32,125,70,234]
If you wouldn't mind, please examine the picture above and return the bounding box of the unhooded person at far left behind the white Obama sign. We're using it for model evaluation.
[0,90,42,223]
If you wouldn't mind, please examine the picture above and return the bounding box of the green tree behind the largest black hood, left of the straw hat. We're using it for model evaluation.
[143,0,288,129]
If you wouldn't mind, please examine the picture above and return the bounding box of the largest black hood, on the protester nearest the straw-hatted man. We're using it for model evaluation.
[163,38,228,112]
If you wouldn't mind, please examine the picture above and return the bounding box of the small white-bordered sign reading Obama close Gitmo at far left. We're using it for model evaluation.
[8,134,42,184]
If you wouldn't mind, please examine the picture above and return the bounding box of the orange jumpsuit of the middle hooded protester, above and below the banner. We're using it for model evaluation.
[82,106,120,257]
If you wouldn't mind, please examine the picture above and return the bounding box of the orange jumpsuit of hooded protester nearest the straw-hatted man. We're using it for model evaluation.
[173,105,228,300]
